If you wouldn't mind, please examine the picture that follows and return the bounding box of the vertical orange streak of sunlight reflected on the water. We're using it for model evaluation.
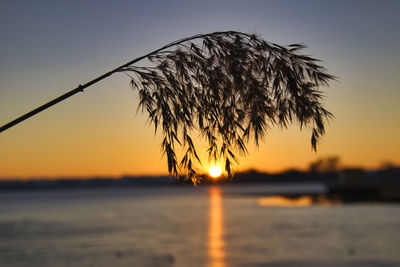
[207,187,226,267]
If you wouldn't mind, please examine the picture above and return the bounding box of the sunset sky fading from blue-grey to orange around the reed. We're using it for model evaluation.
[0,0,400,179]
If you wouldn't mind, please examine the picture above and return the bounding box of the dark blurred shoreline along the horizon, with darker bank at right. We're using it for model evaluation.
[0,168,400,202]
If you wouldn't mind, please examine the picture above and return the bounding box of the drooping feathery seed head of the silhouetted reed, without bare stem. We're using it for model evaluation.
[119,31,334,184]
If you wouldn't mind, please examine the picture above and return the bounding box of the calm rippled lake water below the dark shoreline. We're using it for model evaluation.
[0,185,400,267]
